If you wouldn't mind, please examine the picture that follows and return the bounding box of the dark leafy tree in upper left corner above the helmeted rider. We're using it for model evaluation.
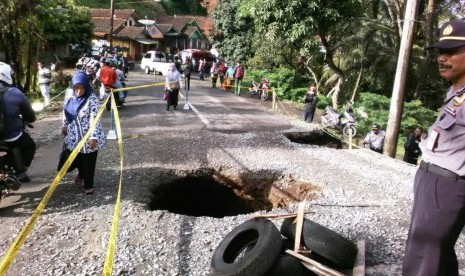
[0,0,93,92]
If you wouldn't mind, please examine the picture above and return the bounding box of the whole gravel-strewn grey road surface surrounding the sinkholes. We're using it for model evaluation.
[0,73,465,275]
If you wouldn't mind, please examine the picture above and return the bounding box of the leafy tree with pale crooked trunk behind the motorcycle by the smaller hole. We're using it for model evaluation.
[241,0,361,106]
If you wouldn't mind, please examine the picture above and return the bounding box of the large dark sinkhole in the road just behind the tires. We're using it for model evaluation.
[148,169,319,218]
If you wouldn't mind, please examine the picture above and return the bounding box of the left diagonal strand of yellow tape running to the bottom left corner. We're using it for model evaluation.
[0,94,108,275]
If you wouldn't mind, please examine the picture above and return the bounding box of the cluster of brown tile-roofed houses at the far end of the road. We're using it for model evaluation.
[91,9,213,60]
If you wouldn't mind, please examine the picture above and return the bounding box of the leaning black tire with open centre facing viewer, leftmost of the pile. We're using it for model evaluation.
[211,219,282,276]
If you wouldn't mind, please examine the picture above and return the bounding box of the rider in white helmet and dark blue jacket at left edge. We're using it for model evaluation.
[0,62,36,182]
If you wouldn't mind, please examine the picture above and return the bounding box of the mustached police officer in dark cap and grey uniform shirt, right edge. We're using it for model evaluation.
[402,20,465,275]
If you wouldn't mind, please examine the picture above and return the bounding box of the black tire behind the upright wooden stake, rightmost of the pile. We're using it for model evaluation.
[281,218,358,268]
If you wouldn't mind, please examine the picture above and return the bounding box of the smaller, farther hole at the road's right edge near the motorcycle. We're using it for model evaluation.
[284,131,343,149]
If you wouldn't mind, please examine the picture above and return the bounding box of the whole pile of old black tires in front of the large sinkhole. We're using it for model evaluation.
[211,218,357,276]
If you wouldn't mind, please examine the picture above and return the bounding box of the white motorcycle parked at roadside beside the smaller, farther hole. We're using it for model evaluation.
[321,104,357,136]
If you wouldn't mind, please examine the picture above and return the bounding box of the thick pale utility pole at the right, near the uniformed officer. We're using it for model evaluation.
[384,0,419,158]
